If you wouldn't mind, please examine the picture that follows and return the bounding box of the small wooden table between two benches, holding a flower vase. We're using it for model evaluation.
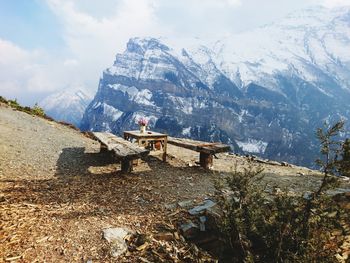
[124,131,168,162]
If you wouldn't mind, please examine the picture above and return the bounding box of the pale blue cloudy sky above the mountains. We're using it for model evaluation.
[0,0,350,105]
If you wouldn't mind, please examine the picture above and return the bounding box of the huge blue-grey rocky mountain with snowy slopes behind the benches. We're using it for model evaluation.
[81,7,350,168]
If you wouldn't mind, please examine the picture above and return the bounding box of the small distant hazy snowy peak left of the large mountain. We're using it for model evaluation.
[39,89,92,126]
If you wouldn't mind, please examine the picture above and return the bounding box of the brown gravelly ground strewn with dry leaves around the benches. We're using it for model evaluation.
[0,105,350,262]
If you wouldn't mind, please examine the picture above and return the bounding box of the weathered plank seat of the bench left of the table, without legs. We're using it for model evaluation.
[92,132,149,159]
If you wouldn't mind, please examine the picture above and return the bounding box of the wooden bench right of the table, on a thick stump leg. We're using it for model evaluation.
[168,137,231,169]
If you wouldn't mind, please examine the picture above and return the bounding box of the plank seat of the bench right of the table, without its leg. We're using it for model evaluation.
[168,137,231,154]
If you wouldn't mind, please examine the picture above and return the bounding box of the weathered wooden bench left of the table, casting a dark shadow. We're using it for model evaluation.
[91,132,149,173]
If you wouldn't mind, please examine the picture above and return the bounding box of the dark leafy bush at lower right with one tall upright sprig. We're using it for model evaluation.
[216,122,344,262]
